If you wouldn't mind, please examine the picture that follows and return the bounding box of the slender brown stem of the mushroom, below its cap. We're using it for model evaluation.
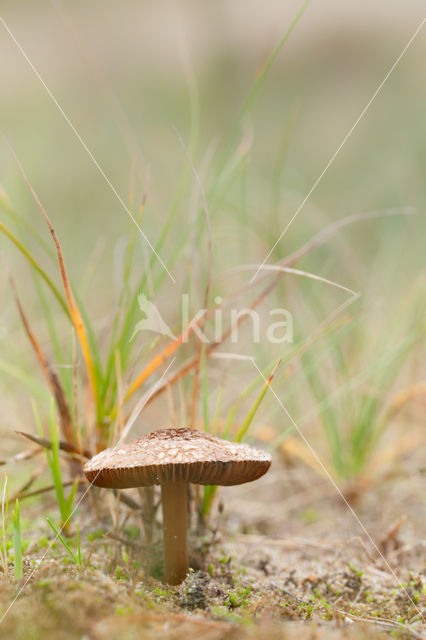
[161,482,188,584]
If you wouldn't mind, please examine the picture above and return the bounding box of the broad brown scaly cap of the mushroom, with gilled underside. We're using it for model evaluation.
[83,429,271,489]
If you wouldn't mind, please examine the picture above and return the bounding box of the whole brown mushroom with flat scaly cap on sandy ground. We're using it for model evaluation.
[84,429,271,585]
